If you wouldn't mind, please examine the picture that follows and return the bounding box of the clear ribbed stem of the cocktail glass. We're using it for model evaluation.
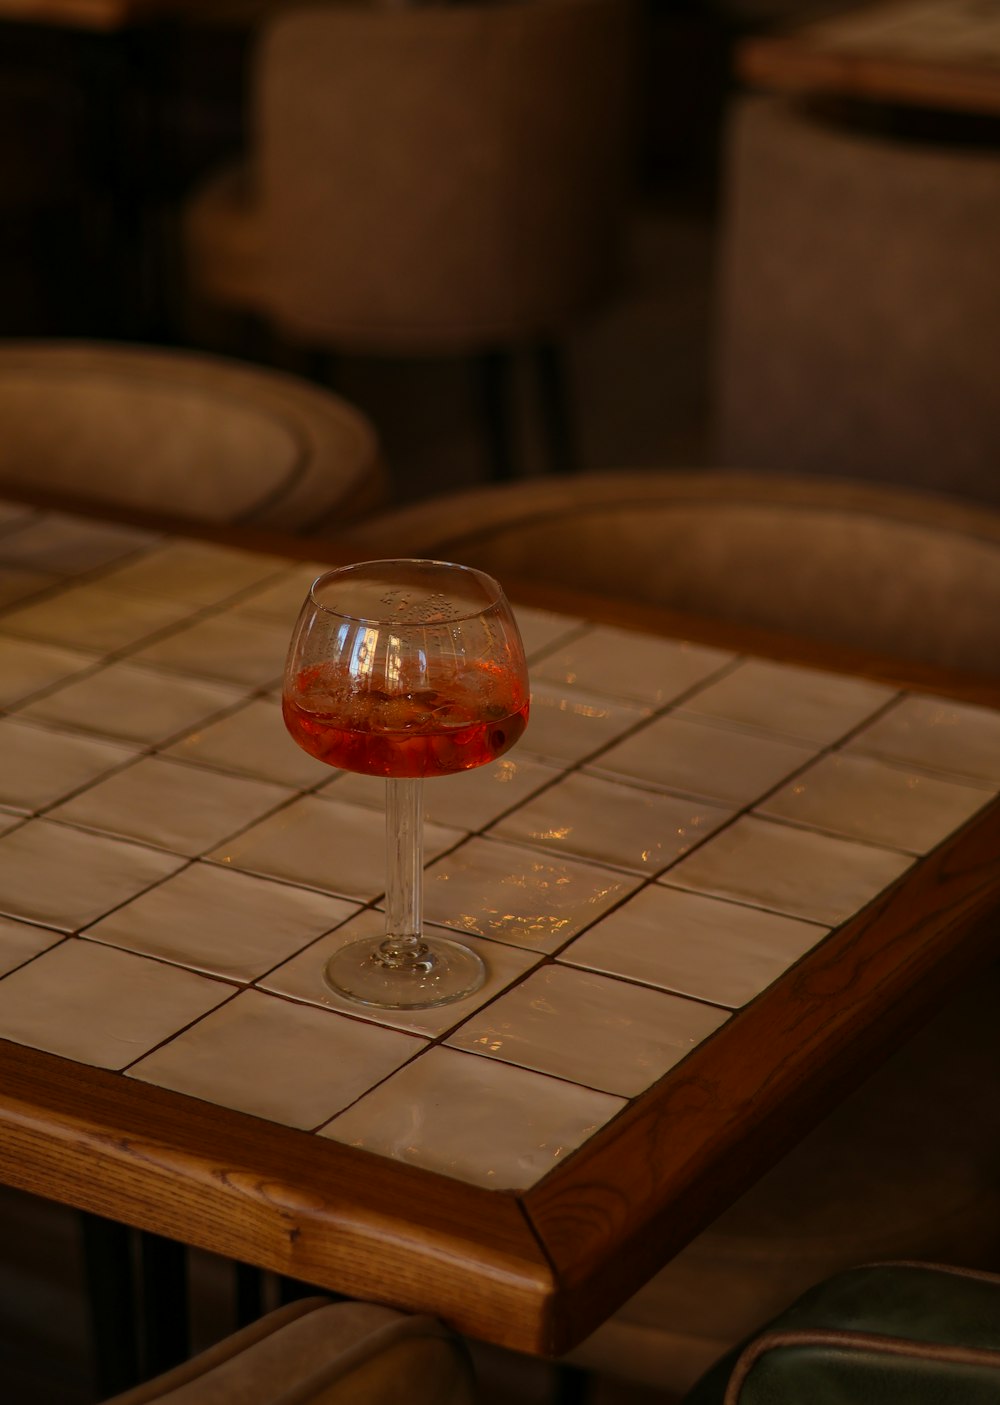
[382,778,424,965]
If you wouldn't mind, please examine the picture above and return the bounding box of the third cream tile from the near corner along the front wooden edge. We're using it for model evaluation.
[0,937,233,1069]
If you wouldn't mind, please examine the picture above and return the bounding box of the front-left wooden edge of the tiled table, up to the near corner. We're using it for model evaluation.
[0,1040,555,1350]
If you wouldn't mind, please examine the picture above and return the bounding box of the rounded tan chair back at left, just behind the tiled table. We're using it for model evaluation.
[0,341,386,531]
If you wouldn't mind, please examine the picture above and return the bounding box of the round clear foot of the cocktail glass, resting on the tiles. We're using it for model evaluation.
[323,937,486,1010]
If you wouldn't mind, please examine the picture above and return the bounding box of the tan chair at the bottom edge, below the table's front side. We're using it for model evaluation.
[107,1297,473,1405]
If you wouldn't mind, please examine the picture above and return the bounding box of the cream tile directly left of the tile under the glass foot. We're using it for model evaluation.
[87,863,358,981]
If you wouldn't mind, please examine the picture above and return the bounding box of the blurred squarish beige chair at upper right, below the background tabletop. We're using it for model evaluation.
[712,97,1000,504]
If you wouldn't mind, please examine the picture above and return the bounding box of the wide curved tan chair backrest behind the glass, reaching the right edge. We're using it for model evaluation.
[341,471,1000,674]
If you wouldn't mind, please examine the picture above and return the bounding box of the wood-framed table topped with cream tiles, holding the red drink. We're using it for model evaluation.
[0,503,1000,1354]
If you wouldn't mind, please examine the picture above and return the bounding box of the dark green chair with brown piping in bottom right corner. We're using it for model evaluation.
[684,1263,1000,1405]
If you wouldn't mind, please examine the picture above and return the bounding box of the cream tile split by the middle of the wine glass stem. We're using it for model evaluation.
[208,795,462,902]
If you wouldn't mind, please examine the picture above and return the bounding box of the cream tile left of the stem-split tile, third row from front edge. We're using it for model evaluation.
[52,756,292,858]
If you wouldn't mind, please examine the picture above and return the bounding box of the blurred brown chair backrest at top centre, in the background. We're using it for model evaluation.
[253,0,636,353]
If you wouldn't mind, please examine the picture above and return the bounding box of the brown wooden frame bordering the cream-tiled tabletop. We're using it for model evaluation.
[0,500,1000,1356]
